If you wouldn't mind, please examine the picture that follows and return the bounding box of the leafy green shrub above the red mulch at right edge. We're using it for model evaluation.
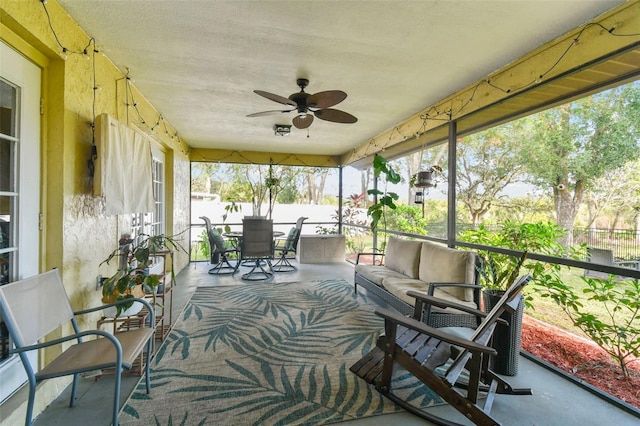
[545,275,640,379]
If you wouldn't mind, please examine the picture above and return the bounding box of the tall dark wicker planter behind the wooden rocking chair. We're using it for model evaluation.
[483,290,524,376]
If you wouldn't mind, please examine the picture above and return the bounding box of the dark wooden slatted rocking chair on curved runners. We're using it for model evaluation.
[351,275,531,425]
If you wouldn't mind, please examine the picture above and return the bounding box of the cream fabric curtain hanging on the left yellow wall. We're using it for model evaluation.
[94,114,155,215]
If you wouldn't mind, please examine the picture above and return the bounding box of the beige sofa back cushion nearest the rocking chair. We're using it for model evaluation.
[418,241,476,302]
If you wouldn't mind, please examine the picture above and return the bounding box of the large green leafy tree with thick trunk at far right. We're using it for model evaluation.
[520,84,640,246]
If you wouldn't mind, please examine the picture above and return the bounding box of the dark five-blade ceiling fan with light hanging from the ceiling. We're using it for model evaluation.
[247,78,358,129]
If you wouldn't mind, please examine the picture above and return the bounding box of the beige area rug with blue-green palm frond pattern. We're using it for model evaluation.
[120,280,442,425]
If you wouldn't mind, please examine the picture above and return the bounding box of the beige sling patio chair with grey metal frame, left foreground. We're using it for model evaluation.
[0,269,155,426]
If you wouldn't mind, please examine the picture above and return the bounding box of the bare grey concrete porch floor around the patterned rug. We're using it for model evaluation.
[6,263,640,426]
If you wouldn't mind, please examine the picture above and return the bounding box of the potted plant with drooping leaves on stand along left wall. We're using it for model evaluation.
[100,234,186,317]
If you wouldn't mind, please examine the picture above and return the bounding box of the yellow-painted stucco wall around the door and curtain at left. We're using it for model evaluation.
[0,0,190,421]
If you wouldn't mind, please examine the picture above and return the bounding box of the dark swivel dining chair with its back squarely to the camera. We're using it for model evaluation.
[238,217,274,281]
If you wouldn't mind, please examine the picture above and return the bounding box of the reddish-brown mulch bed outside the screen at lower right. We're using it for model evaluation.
[522,315,640,408]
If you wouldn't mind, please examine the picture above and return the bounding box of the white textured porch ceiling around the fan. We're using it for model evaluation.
[59,0,622,155]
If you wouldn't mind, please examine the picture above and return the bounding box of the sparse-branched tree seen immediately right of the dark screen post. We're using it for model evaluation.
[456,121,525,227]
